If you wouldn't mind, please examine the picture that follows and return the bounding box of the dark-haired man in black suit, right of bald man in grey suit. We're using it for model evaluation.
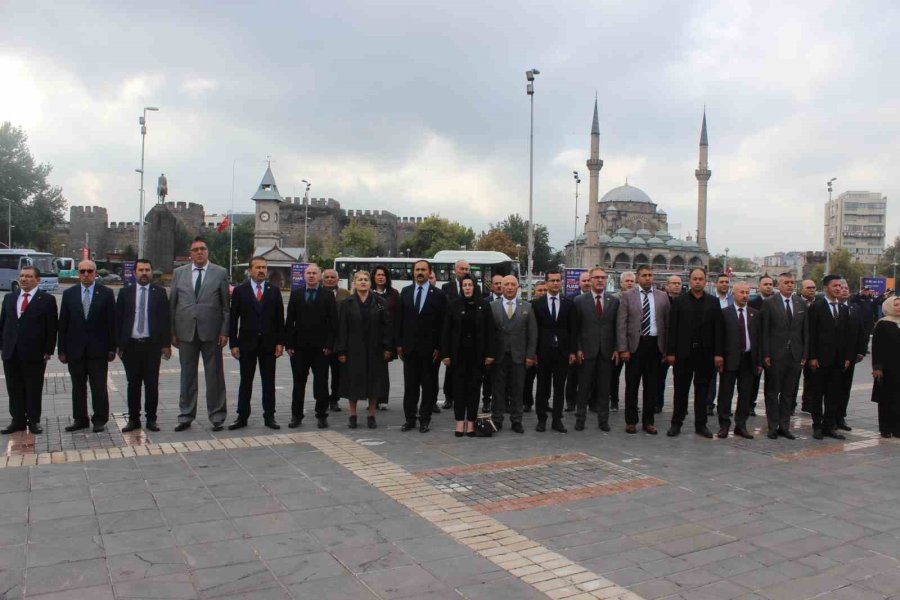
[531,269,575,433]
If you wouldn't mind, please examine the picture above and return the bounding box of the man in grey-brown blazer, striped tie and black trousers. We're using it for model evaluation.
[616,265,669,435]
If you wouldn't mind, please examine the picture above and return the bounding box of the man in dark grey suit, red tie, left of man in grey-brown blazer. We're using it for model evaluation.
[575,267,619,431]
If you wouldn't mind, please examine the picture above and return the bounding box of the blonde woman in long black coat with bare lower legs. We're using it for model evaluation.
[334,271,393,429]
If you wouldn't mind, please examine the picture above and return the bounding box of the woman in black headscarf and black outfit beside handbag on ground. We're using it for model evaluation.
[441,274,494,437]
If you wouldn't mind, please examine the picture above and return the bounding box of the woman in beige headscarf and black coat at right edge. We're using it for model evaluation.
[872,296,900,437]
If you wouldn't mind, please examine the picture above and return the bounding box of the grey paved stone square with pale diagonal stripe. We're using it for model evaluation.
[0,338,900,600]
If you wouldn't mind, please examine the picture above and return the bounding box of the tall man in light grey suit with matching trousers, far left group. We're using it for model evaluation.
[169,237,229,431]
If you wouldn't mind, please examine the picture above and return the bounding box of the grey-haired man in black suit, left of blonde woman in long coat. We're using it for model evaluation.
[279,264,338,429]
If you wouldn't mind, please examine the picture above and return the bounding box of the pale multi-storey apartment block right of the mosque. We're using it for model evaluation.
[825,191,887,265]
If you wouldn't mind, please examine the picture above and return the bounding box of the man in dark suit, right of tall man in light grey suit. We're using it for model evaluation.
[228,256,284,431]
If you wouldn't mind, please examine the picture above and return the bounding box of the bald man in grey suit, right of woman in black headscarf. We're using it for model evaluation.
[491,275,537,433]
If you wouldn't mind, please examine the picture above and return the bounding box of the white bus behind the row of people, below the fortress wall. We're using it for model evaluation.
[334,250,519,291]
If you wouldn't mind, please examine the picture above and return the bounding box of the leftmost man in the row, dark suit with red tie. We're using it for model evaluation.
[0,267,57,435]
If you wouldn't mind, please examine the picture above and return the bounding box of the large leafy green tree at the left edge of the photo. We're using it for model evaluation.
[0,121,66,250]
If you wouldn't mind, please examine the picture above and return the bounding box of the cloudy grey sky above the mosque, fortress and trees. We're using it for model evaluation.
[0,0,900,255]
